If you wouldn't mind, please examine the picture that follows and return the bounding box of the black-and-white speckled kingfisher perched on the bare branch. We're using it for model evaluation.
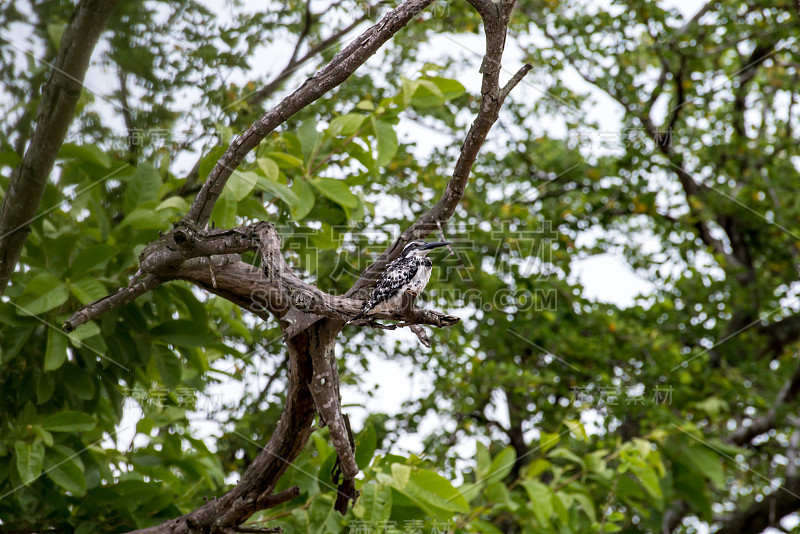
[347,241,452,323]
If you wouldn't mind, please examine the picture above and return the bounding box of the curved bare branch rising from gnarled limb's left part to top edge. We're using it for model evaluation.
[185,0,433,226]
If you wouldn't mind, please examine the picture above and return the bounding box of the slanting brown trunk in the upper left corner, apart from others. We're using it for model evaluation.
[0,0,118,294]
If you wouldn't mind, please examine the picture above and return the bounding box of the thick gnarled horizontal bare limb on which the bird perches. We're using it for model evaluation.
[64,222,459,337]
